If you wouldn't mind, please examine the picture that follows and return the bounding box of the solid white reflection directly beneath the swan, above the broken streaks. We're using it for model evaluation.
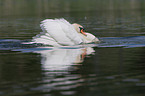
[35,47,94,71]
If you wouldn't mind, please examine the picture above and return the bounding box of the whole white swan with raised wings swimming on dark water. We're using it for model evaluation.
[32,19,99,46]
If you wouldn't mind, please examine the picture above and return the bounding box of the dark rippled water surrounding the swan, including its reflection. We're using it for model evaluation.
[0,0,145,96]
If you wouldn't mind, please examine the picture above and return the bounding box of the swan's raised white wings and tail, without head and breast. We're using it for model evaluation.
[33,19,83,46]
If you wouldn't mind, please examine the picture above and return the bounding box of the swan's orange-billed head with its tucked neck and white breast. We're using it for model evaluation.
[72,23,100,43]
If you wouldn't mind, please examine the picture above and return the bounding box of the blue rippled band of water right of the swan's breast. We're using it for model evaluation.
[98,36,145,48]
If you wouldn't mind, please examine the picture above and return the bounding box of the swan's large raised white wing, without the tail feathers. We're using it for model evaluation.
[40,19,82,45]
